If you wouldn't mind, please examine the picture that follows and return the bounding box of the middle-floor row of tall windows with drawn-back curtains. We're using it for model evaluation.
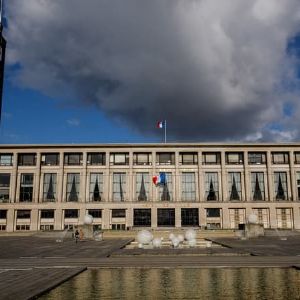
[0,172,300,202]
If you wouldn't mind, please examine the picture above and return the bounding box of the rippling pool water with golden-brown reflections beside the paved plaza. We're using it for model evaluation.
[41,268,300,300]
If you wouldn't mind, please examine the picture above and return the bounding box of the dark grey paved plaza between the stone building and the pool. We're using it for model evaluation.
[0,235,300,300]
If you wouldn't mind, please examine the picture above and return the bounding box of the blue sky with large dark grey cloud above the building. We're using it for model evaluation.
[0,0,300,144]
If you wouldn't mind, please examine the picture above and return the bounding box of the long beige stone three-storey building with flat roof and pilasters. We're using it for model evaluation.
[0,143,300,232]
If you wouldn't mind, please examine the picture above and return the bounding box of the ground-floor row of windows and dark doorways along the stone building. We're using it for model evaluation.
[0,208,293,230]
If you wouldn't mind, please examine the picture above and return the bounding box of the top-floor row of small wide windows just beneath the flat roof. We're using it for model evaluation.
[0,152,300,166]
